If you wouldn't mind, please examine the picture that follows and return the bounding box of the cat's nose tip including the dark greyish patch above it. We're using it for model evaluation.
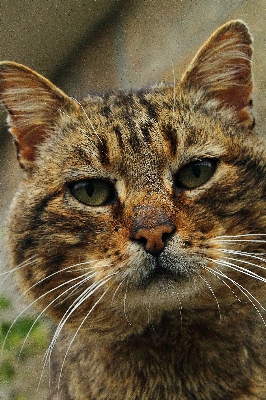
[131,206,175,254]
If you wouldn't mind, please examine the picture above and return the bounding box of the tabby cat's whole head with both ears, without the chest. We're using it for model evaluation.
[0,21,266,336]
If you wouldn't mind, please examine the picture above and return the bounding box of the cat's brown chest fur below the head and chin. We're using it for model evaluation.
[51,307,266,400]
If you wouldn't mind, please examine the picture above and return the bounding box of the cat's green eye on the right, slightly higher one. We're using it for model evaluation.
[175,159,217,190]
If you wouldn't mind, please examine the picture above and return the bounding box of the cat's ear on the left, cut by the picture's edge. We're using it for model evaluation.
[0,62,76,169]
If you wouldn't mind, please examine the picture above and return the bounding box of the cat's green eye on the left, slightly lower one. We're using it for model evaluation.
[70,179,114,206]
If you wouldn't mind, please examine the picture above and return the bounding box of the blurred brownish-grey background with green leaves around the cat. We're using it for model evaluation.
[0,0,266,400]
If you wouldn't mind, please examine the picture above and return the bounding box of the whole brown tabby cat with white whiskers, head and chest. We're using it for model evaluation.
[0,20,266,400]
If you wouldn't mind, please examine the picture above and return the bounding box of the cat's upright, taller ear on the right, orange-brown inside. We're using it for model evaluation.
[180,20,254,128]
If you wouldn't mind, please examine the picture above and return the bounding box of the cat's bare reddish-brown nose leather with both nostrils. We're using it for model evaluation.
[134,225,173,254]
